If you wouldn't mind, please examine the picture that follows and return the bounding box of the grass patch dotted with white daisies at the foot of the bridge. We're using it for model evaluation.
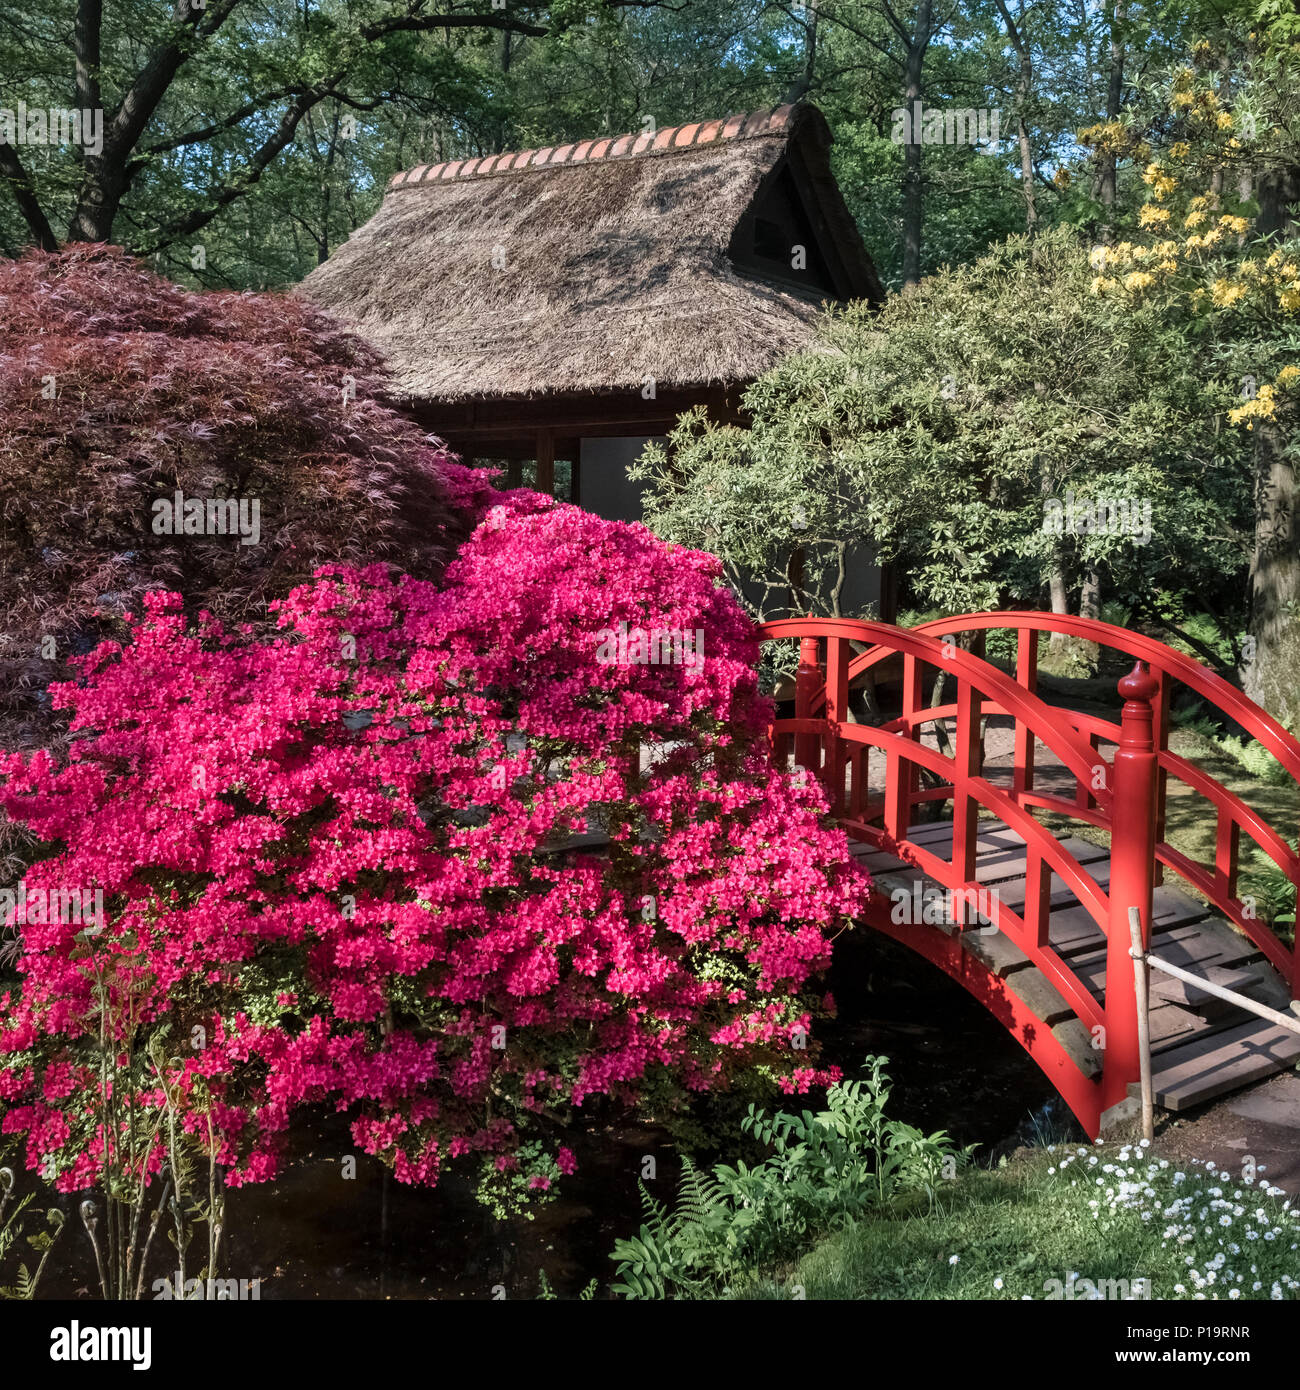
[751,1144,1300,1300]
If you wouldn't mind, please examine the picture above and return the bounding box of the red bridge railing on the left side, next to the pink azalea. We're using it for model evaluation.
[762,619,1150,1133]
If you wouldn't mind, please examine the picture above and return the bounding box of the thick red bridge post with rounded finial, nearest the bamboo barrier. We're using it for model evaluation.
[1101,662,1160,1119]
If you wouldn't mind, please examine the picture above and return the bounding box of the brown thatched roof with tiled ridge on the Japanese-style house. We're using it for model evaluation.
[300,106,881,400]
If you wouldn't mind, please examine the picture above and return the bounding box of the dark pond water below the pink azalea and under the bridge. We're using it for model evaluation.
[27,929,1061,1300]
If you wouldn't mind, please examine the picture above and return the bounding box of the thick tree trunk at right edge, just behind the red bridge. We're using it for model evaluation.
[1242,421,1300,730]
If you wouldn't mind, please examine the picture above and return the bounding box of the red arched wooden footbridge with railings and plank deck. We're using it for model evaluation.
[761,612,1300,1137]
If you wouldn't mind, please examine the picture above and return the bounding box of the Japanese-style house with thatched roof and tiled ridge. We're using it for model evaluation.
[302,106,883,561]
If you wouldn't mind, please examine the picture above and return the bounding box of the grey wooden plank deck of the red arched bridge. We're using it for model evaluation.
[854,820,1300,1111]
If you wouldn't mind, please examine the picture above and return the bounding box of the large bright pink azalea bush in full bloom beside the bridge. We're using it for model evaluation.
[0,483,868,1193]
